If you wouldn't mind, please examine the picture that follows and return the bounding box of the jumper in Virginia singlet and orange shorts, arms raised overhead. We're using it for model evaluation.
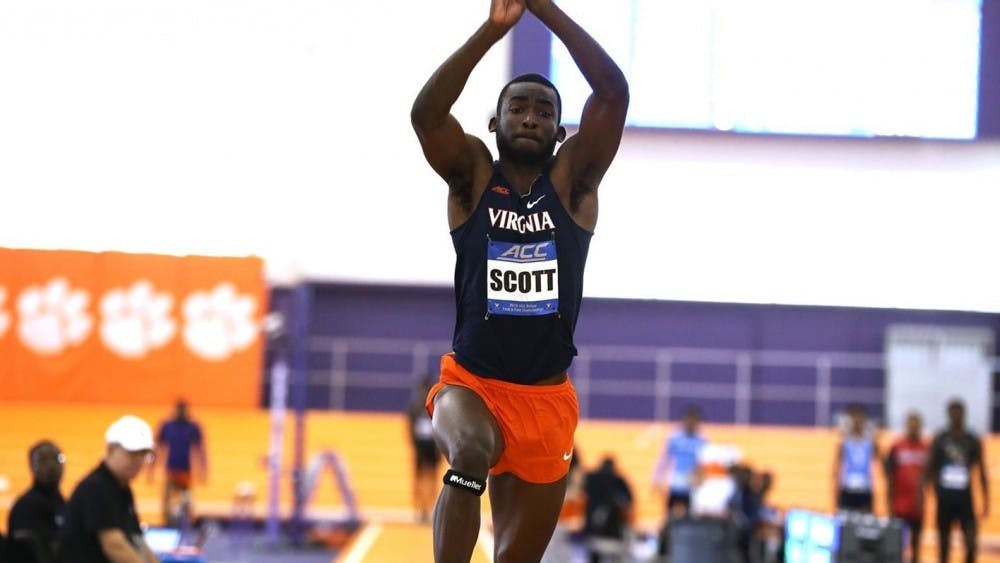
[410,0,628,563]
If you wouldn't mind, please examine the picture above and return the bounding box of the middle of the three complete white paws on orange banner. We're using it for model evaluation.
[100,280,177,359]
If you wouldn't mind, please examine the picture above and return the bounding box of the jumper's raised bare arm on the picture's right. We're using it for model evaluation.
[526,0,629,207]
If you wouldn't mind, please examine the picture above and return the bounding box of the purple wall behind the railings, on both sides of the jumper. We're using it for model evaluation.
[264,284,1000,425]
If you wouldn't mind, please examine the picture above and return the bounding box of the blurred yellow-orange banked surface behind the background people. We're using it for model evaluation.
[0,404,1000,561]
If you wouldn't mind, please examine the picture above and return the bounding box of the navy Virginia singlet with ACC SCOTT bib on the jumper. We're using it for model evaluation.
[451,163,592,384]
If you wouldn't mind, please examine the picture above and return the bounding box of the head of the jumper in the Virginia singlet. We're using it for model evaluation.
[490,82,566,164]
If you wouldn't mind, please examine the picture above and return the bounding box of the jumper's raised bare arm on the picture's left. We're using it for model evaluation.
[410,0,525,218]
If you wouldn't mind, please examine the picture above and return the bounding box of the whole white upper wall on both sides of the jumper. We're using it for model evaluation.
[0,0,1000,311]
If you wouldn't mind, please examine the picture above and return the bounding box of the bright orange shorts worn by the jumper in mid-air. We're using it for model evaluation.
[426,354,580,484]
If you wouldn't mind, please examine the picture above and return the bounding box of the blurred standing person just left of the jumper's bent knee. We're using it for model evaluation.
[407,375,441,524]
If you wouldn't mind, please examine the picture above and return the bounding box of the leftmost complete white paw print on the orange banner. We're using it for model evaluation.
[17,278,94,355]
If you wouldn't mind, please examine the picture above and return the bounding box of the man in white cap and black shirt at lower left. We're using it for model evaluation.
[58,415,159,563]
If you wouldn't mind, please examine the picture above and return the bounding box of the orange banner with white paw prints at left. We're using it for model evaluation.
[0,248,267,407]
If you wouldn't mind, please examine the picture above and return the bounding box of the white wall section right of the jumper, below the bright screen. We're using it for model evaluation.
[588,129,1000,311]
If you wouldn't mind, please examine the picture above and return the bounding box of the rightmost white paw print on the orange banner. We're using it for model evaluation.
[183,283,258,361]
